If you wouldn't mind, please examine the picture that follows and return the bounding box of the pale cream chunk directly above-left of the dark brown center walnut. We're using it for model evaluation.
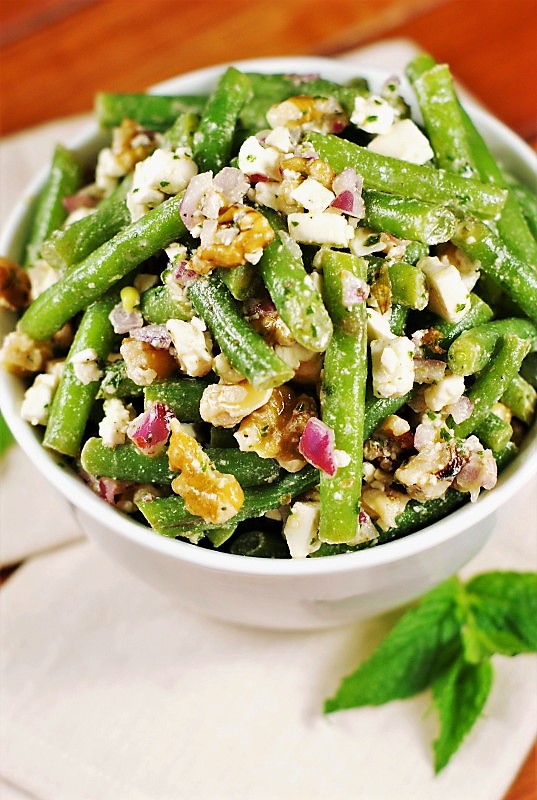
[200,381,272,428]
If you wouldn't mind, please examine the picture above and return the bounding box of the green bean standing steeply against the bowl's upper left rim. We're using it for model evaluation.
[24,145,81,267]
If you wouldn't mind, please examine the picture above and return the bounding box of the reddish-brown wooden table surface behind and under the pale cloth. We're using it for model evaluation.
[0,0,537,800]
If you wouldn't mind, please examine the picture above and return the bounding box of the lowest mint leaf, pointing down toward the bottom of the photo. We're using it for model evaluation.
[432,656,493,773]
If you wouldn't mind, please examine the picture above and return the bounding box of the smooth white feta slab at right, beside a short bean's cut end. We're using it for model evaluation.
[418,256,470,322]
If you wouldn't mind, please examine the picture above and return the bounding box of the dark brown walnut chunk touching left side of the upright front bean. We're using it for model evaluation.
[234,386,317,472]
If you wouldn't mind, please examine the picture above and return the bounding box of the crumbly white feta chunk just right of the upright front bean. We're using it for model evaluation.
[370,336,415,397]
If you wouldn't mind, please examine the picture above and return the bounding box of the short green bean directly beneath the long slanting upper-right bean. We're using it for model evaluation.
[362,189,457,245]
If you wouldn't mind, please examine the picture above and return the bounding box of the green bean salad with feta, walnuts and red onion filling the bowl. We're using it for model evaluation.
[0,55,537,558]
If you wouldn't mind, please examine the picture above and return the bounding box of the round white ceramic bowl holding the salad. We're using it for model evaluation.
[0,58,537,629]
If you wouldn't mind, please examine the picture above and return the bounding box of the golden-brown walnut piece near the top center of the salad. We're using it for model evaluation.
[189,204,274,275]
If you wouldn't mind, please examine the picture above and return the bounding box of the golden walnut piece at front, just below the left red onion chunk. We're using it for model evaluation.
[168,420,244,525]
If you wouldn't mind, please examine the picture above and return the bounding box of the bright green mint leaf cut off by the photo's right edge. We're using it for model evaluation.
[462,572,537,663]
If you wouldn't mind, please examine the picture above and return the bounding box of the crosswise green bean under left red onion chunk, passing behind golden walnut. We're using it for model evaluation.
[80,437,280,487]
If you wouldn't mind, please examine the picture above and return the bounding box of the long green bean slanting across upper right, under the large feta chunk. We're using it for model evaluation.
[308,133,506,219]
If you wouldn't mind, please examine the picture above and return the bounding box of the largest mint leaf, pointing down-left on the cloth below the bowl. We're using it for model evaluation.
[325,578,461,713]
